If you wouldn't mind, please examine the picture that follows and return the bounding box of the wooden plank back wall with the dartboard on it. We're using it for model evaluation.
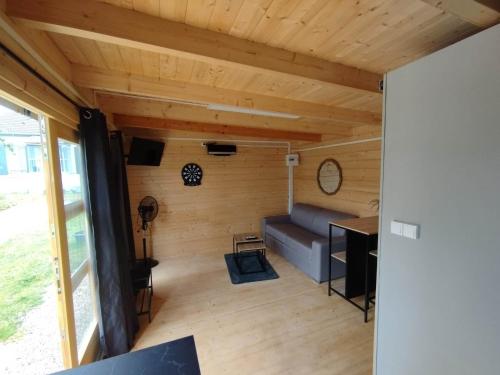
[127,140,288,259]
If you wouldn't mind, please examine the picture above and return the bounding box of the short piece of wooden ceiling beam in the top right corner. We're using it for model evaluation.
[422,0,500,28]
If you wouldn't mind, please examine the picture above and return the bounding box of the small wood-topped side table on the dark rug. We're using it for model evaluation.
[233,233,266,274]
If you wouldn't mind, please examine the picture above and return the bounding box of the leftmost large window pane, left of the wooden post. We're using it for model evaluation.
[0,103,64,375]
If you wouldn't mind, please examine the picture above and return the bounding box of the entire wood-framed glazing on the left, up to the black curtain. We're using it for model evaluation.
[0,75,99,374]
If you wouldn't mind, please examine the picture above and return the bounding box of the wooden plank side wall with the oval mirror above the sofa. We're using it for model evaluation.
[294,141,381,216]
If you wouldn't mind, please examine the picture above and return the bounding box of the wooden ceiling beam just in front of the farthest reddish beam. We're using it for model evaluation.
[97,94,354,137]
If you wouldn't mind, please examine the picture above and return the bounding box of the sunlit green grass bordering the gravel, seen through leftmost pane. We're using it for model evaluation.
[0,232,52,342]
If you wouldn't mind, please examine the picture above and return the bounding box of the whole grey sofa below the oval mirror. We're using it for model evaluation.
[261,203,355,283]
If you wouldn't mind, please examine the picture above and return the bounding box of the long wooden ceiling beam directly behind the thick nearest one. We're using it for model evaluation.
[72,65,381,126]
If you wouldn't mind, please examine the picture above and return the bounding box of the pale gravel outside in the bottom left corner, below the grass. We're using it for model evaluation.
[0,285,63,375]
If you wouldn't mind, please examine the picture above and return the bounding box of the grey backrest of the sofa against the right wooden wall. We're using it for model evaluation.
[290,203,356,237]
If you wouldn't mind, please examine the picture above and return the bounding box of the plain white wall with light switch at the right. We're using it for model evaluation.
[376,25,500,375]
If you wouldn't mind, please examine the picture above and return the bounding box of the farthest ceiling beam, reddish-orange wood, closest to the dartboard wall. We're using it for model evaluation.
[113,114,321,142]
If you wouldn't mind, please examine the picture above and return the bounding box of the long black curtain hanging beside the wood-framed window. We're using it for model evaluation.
[80,108,138,357]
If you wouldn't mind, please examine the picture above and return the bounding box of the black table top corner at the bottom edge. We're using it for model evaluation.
[50,336,201,375]
